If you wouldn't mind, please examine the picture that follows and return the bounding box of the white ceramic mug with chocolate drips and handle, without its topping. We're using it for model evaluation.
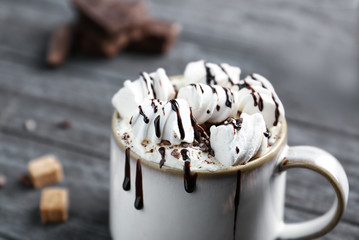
[110,113,349,240]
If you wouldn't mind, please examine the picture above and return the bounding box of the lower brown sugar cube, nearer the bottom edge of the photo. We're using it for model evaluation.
[40,188,69,223]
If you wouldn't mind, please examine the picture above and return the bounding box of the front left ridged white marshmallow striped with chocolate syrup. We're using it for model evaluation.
[130,99,194,145]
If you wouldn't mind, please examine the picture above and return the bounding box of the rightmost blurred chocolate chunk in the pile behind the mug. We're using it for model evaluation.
[128,19,179,53]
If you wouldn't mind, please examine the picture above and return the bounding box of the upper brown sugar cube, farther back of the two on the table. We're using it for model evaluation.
[28,155,63,188]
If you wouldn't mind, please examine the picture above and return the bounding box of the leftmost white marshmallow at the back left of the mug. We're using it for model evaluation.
[112,68,176,119]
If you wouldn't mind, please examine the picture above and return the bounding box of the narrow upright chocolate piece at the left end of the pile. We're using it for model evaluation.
[46,24,73,67]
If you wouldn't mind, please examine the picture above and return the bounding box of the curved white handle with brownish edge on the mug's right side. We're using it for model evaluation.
[279,146,349,239]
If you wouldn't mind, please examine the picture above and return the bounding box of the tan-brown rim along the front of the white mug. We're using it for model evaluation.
[111,110,287,177]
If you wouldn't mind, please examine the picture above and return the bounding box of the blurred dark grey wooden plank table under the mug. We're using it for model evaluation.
[0,0,359,240]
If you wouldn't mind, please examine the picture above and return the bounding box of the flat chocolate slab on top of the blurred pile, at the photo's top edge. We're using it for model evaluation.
[73,0,147,35]
